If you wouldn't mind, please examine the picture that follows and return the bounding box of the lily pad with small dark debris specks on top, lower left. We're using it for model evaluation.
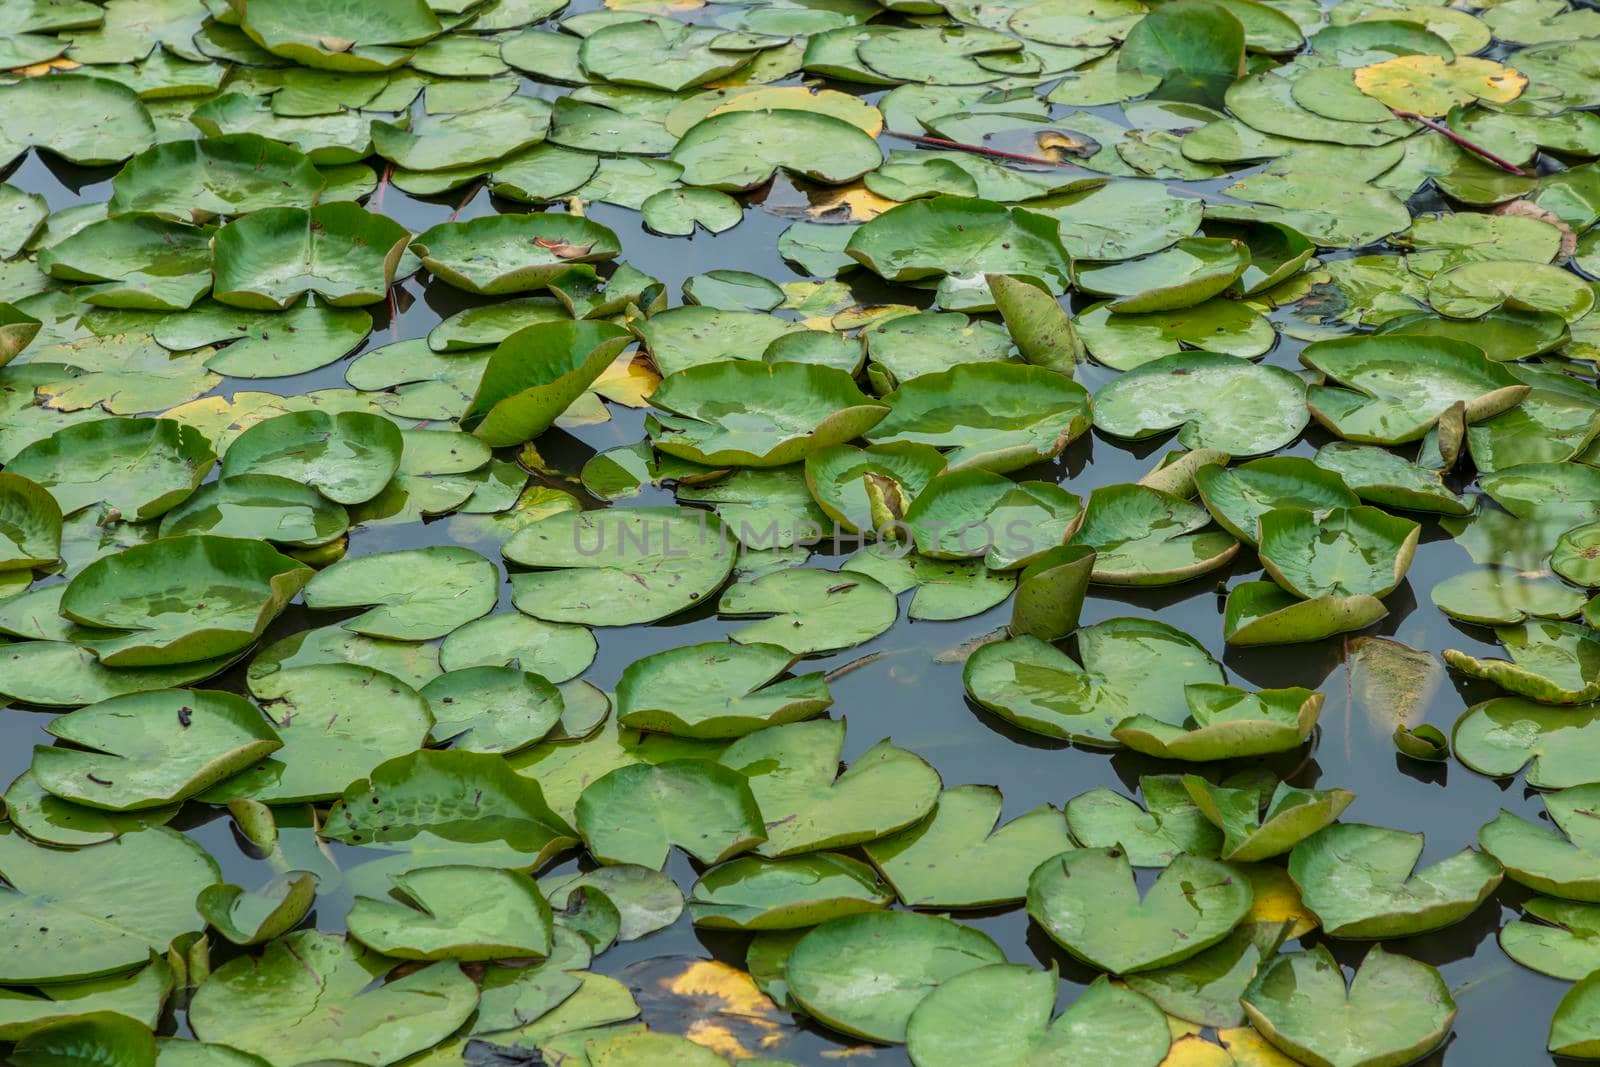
[32,689,282,811]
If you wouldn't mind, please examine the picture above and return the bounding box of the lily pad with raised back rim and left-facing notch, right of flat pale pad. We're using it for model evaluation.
[1301,334,1528,445]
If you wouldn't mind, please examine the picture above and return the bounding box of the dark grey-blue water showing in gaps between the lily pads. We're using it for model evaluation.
[0,37,1566,1067]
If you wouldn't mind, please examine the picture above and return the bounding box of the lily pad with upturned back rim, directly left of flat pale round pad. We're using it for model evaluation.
[866,363,1090,474]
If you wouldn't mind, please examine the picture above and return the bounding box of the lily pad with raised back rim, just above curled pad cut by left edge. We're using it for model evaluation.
[6,419,216,522]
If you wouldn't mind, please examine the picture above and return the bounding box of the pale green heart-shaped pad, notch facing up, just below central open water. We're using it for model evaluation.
[861,785,1072,909]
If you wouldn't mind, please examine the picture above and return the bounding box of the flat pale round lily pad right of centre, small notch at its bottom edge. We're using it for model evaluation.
[1094,352,1309,456]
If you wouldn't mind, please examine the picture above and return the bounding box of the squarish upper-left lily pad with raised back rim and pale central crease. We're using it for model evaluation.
[211,203,411,310]
